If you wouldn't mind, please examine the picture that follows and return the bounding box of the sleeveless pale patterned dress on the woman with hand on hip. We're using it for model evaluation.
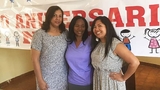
[91,38,126,90]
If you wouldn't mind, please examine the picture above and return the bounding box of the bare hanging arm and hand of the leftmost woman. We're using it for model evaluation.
[31,49,48,90]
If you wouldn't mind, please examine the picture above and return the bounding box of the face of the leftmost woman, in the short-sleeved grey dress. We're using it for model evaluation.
[51,10,63,27]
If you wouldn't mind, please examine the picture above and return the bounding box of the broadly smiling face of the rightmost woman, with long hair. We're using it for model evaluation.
[93,20,107,42]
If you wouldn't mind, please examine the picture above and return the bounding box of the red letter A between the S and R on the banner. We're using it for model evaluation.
[108,8,124,27]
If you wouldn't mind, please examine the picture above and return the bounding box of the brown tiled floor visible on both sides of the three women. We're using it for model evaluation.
[0,63,160,90]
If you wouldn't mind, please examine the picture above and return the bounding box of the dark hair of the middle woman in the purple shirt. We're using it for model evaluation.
[67,16,88,43]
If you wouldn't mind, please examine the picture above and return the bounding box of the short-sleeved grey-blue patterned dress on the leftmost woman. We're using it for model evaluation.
[31,29,68,90]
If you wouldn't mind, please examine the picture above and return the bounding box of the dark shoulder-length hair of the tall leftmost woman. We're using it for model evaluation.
[41,6,66,33]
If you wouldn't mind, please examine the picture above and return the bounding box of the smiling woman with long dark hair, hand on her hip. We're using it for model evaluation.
[91,16,139,90]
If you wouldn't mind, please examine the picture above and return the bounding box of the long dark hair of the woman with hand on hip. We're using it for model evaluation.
[91,16,120,56]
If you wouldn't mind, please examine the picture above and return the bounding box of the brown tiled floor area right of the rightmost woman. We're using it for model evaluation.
[136,63,160,90]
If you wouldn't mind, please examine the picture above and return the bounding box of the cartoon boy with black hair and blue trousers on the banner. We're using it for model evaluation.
[120,29,135,50]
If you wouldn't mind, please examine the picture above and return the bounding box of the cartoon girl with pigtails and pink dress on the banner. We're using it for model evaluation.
[144,28,160,53]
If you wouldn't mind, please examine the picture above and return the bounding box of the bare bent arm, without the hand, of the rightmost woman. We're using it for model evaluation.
[114,43,140,81]
